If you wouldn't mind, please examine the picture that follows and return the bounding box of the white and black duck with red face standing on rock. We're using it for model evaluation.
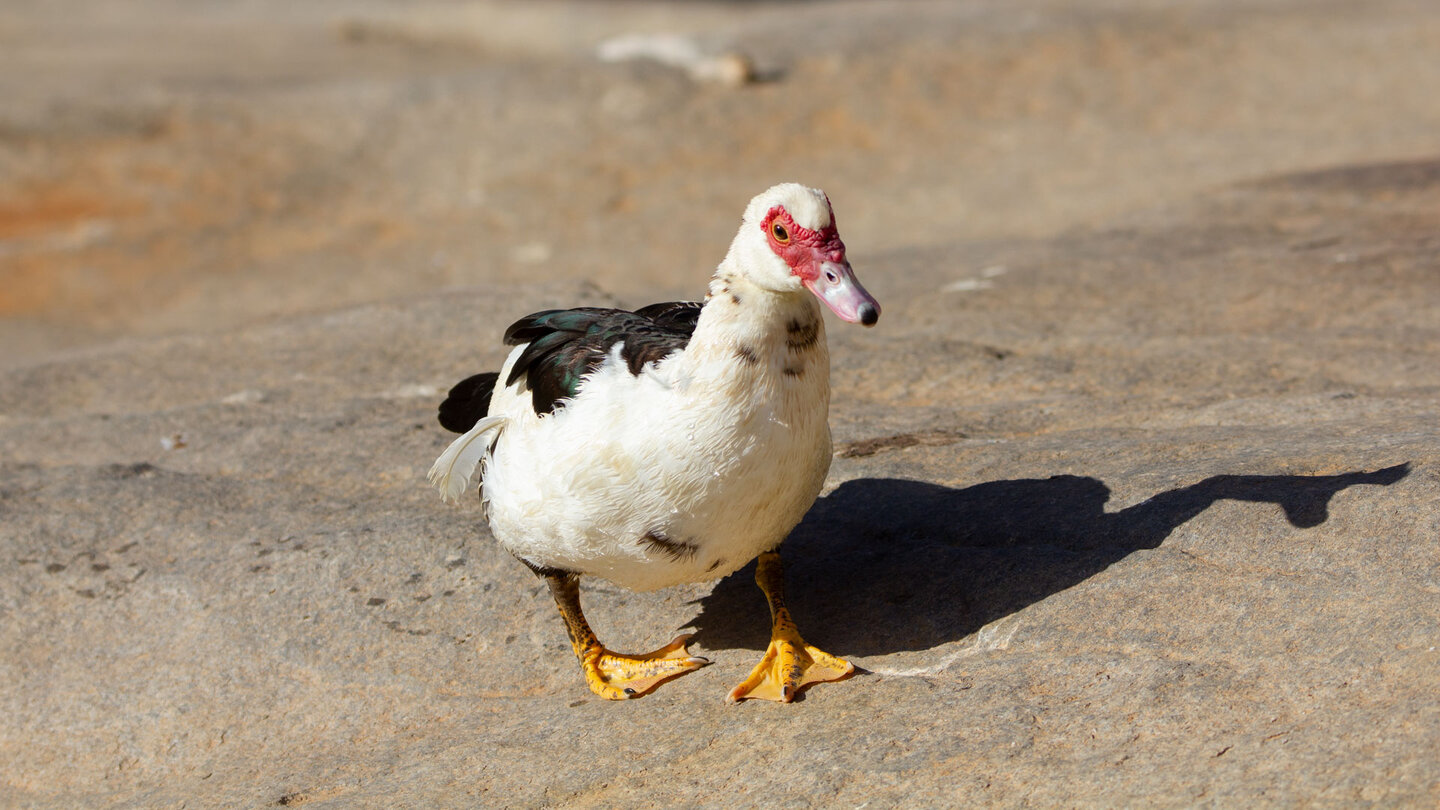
[428,183,880,703]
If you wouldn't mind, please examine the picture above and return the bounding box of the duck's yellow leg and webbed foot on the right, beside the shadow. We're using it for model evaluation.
[730,551,855,703]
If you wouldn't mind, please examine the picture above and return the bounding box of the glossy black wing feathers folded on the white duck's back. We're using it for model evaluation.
[504,301,701,415]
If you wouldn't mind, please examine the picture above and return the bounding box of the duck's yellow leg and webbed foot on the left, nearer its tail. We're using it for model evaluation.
[531,566,710,700]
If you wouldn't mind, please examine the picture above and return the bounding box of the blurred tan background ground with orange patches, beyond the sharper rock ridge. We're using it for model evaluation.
[0,0,1440,366]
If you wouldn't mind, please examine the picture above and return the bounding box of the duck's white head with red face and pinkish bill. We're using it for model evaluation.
[730,183,880,326]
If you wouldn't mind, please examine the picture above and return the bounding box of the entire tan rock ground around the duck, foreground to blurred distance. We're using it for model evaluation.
[0,0,1440,807]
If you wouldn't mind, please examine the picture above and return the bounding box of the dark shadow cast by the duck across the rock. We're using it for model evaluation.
[691,464,1410,656]
